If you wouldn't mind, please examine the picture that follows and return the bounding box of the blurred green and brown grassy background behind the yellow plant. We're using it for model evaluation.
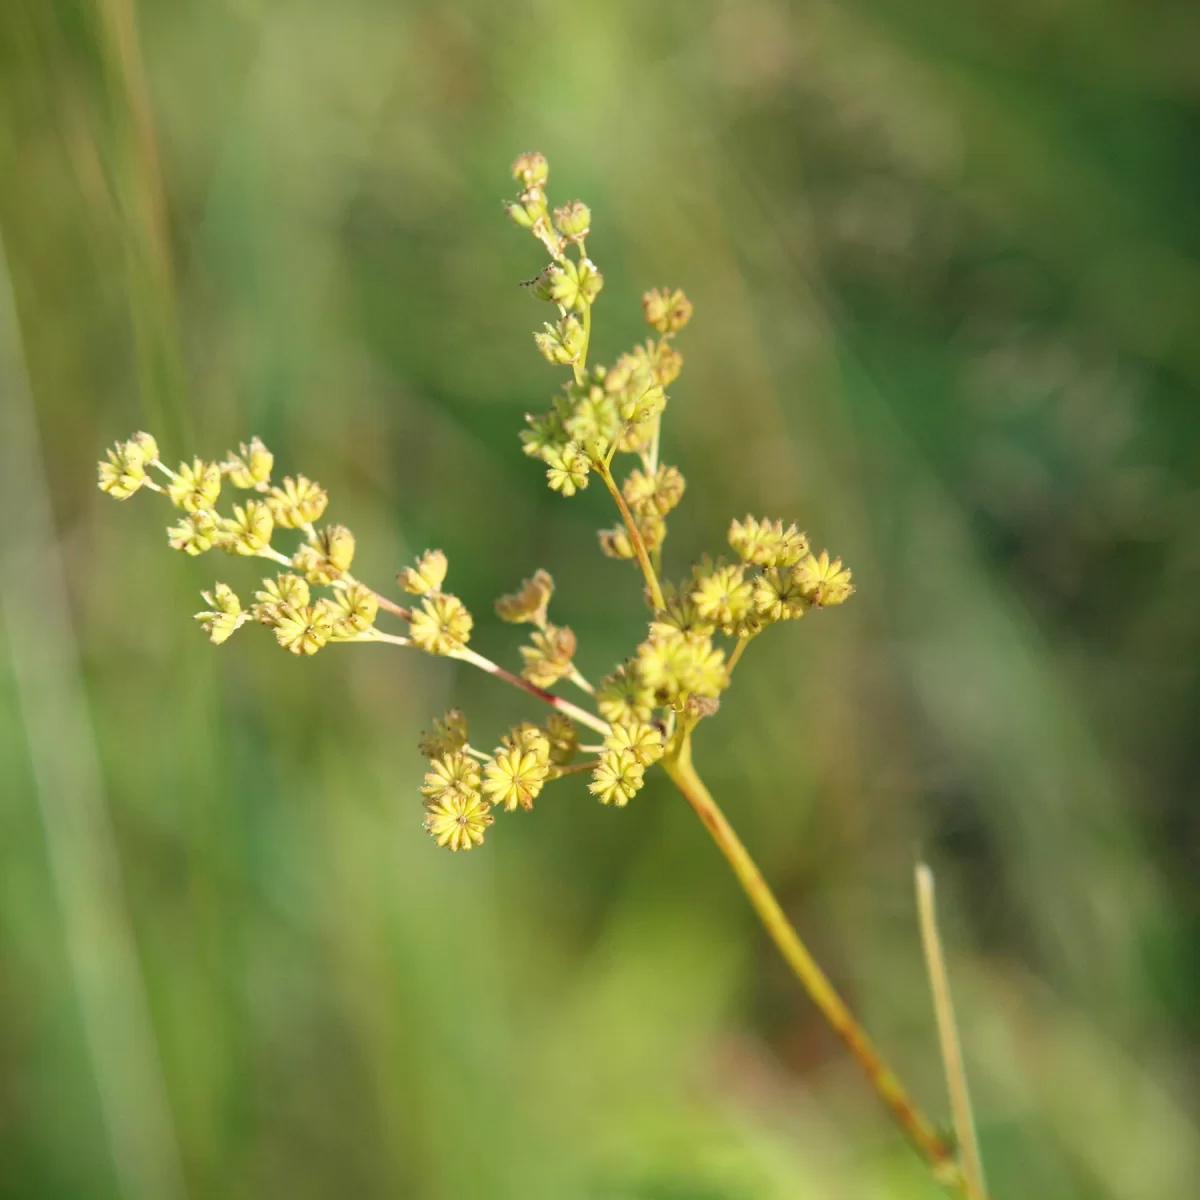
[0,0,1200,1200]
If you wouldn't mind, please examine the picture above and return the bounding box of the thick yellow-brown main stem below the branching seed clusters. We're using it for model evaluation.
[662,733,977,1185]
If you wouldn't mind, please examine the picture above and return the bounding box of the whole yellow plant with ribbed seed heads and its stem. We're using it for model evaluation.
[100,154,983,1200]
